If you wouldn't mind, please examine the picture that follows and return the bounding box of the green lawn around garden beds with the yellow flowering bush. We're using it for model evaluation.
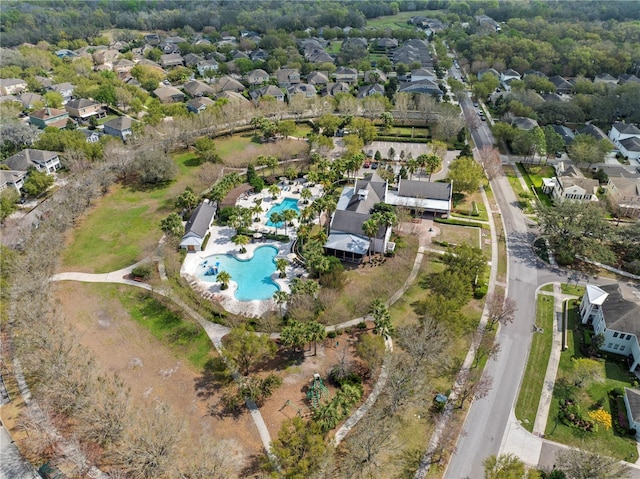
[545,300,638,462]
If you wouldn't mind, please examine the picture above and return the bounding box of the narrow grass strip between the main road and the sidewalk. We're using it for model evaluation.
[516,295,554,432]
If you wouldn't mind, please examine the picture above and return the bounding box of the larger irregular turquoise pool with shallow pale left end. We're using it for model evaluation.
[196,246,280,301]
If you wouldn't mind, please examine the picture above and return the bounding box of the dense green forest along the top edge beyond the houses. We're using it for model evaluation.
[0,0,640,47]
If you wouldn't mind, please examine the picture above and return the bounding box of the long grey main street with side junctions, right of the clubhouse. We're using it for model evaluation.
[444,92,640,479]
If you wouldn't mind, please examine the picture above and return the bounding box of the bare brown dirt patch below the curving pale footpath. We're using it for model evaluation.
[55,282,262,474]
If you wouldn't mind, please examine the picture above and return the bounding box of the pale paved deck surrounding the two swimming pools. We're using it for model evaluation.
[180,184,321,317]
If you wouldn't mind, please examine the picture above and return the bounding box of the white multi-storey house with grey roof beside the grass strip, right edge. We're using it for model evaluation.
[579,283,640,371]
